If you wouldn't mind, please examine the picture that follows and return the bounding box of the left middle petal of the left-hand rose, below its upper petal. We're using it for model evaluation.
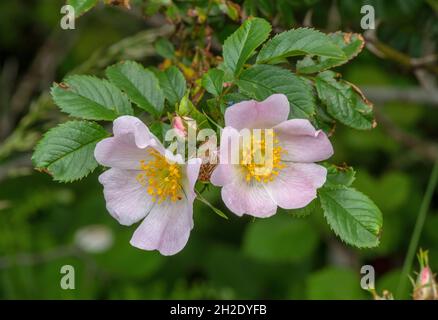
[99,168,154,225]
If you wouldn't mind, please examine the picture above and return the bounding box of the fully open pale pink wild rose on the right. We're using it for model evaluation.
[211,94,333,217]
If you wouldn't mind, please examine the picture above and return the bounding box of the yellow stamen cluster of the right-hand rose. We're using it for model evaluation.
[240,130,286,183]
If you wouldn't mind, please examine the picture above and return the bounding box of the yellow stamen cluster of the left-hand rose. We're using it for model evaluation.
[137,149,183,203]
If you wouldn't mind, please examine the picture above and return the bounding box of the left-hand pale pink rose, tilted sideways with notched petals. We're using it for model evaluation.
[94,116,201,255]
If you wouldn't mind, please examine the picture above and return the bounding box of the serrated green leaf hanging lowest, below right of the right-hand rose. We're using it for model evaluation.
[319,186,382,248]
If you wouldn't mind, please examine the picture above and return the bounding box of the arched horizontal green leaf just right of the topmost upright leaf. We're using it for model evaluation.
[257,28,345,63]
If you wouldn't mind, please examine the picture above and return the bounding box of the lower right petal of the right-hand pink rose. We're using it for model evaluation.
[267,163,327,209]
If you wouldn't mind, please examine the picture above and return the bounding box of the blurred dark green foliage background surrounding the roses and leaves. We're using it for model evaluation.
[0,0,438,299]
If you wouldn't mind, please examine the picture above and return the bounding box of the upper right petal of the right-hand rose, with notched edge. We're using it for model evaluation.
[274,119,333,162]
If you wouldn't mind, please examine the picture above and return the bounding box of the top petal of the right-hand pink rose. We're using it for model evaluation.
[225,94,290,130]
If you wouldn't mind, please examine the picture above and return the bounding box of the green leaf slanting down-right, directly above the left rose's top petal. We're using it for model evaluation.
[106,61,164,115]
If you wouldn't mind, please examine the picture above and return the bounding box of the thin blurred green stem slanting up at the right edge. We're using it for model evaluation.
[397,161,438,297]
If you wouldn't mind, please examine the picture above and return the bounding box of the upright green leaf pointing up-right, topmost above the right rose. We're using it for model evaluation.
[223,18,271,75]
